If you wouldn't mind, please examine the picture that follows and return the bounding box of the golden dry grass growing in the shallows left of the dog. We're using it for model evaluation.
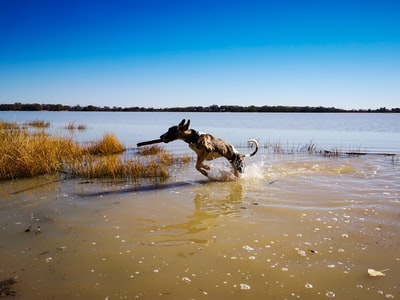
[0,121,191,180]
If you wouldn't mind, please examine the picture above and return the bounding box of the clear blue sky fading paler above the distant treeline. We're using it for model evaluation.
[0,0,400,109]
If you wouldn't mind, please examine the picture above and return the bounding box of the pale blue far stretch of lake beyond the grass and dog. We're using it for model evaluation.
[0,111,400,153]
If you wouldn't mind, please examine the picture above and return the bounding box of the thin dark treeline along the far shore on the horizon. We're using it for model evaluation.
[0,102,400,113]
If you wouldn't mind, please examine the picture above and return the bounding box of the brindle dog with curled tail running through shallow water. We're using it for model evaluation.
[160,119,258,178]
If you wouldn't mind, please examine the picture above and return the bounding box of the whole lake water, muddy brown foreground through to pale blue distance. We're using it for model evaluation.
[0,112,400,299]
